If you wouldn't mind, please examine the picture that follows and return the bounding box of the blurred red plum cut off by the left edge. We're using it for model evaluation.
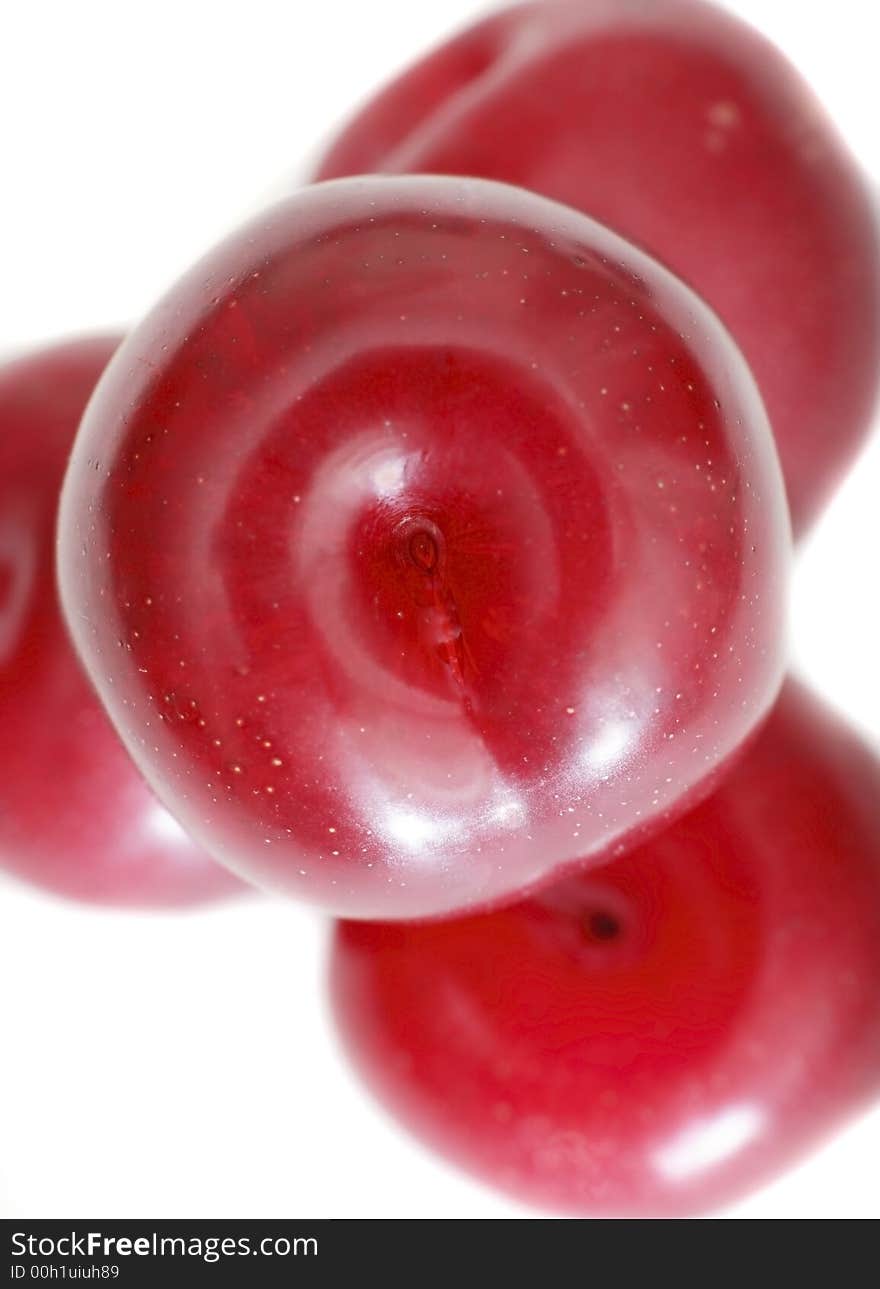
[0,336,244,907]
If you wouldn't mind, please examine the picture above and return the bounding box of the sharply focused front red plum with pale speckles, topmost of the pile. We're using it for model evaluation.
[59,178,787,918]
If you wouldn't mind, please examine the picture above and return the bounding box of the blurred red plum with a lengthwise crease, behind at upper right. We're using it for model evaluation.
[318,0,880,535]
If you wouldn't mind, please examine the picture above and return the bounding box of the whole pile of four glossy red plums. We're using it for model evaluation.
[0,0,880,1216]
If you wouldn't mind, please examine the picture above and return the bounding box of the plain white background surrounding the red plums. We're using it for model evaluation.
[0,0,880,1217]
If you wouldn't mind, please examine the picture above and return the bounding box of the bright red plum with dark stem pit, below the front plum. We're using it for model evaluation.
[331,682,880,1216]
